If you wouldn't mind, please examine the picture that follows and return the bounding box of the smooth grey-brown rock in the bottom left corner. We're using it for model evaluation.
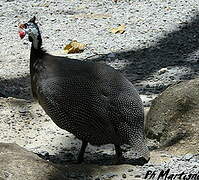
[0,143,66,180]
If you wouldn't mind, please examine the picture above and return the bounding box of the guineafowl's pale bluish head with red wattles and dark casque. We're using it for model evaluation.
[19,16,42,49]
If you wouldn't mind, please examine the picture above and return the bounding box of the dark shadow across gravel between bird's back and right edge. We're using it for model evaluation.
[91,14,199,94]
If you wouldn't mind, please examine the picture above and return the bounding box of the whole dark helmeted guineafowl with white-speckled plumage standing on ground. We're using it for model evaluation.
[19,17,149,165]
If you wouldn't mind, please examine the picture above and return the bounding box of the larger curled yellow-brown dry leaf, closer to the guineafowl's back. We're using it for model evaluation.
[64,40,86,54]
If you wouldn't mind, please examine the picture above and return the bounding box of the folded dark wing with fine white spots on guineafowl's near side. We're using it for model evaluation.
[38,76,118,143]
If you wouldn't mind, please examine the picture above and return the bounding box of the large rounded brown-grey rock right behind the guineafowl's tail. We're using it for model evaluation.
[145,79,199,153]
